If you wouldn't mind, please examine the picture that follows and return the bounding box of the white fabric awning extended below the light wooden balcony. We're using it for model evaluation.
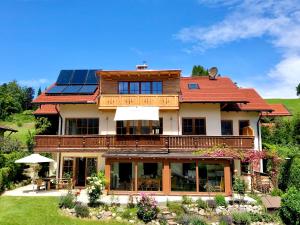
[114,106,159,121]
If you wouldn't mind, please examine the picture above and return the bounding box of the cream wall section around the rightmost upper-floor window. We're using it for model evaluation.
[221,112,261,150]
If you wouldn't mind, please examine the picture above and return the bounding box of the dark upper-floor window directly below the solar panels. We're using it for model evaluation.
[65,118,99,135]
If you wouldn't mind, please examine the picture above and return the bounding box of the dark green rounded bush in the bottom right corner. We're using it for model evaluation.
[279,187,300,225]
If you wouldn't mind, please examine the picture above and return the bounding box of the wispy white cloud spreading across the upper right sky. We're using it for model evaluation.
[176,0,300,97]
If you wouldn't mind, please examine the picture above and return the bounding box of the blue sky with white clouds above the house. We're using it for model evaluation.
[0,0,300,98]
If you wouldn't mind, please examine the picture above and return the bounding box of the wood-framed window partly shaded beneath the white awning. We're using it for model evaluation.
[116,118,163,135]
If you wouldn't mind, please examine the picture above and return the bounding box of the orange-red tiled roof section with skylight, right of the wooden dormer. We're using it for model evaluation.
[180,76,248,103]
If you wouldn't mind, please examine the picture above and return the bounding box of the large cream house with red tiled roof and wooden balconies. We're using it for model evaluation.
[33,65,272,195]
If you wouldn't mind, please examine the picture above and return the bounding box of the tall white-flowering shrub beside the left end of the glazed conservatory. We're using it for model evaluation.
[87,172,106,205]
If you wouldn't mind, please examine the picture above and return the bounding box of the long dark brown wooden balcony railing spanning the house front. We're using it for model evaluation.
[34,135,254,152]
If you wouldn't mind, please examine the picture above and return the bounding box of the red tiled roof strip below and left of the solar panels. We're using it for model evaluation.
[32,84,99,104]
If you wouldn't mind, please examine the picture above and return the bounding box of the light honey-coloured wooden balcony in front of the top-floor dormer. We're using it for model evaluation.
[99,95,179,109]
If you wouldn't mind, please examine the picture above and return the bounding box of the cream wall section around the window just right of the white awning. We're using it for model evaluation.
[179,103,221,136]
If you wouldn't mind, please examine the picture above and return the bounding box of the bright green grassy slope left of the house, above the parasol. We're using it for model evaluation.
[0,110,34,145]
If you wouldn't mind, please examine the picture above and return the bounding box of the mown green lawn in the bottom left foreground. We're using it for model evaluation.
[0,196,124,225]
